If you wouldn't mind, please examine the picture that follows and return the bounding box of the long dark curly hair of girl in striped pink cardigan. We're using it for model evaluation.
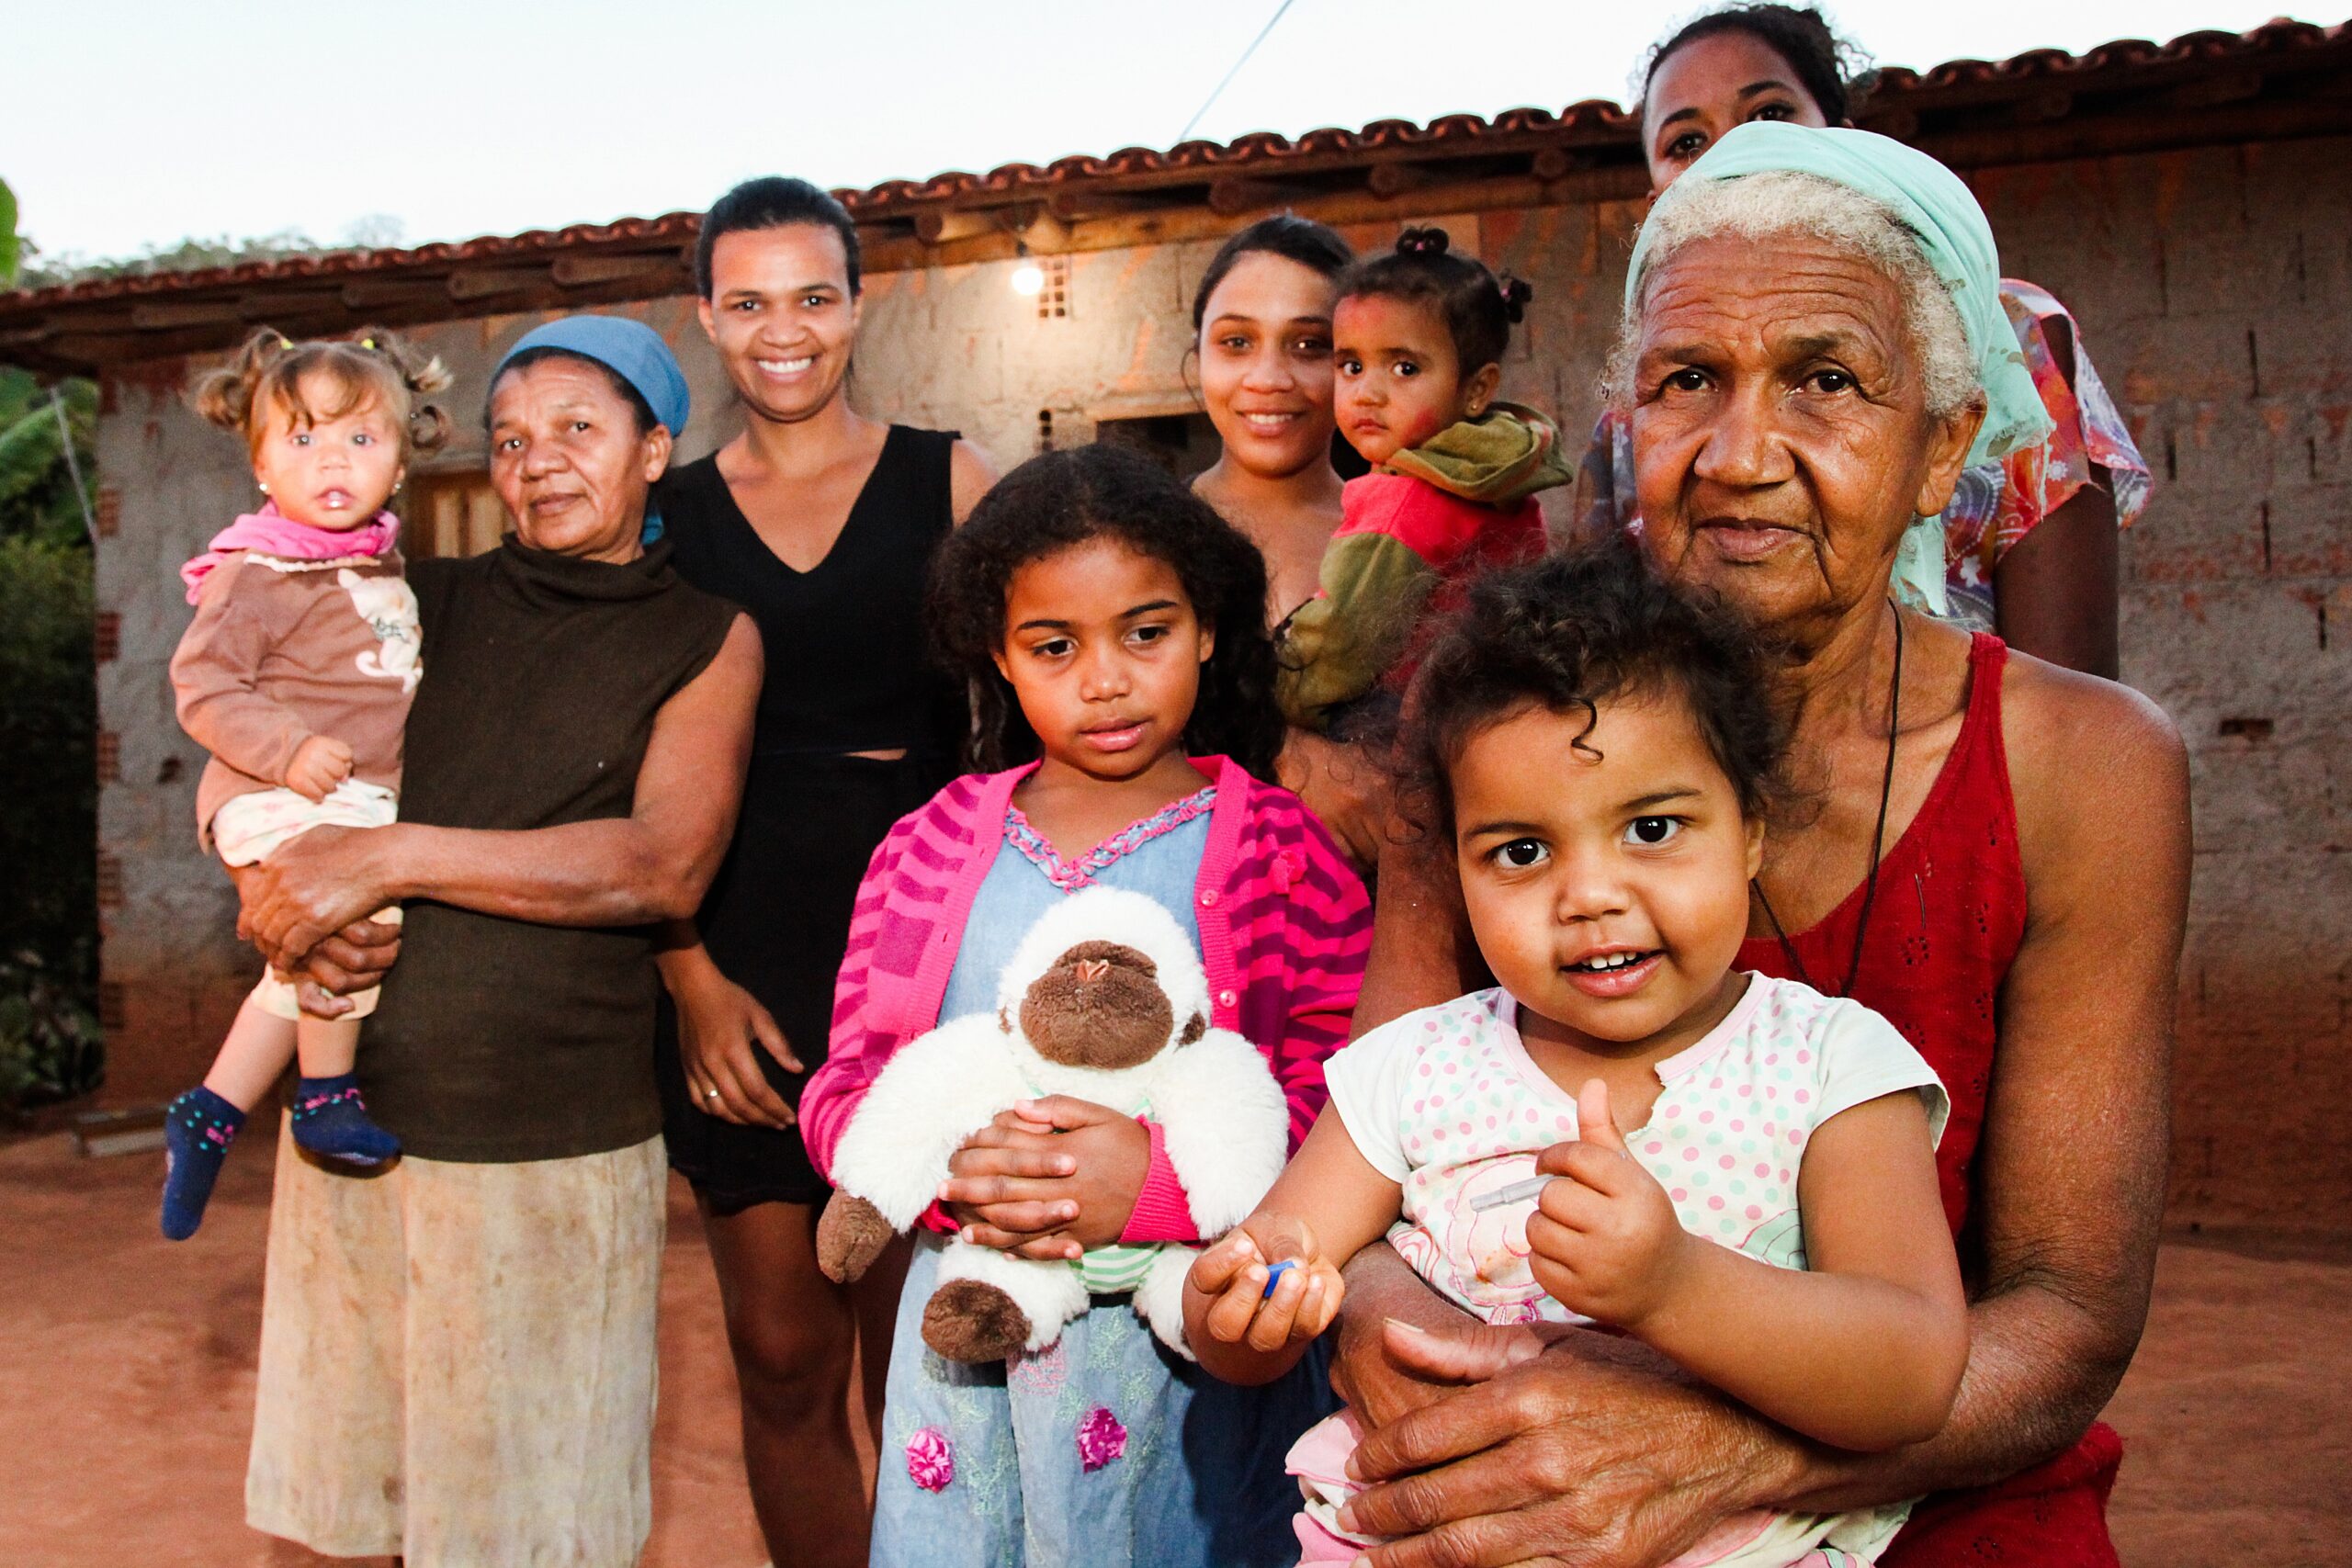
[924,445,1282,781]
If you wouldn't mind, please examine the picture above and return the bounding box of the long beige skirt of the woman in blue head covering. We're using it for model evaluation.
[244,1134,668,1568]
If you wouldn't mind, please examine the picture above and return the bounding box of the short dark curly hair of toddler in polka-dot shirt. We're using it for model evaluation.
[1397,536,1790,841]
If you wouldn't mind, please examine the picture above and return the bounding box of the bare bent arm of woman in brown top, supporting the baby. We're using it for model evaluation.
[244,616,762,968]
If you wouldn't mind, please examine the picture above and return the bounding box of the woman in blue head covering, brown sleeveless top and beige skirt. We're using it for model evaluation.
[240,317,762,1568]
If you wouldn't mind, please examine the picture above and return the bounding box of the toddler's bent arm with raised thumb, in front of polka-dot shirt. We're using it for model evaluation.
[1526,1079,1969,1453]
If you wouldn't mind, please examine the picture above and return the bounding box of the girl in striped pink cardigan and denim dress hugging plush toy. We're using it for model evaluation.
[799,446,1371,1568]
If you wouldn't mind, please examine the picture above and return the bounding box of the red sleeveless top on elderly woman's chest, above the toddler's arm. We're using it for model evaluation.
[1740,632,2025,1235]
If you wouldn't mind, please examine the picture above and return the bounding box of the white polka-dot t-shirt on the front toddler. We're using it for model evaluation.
[1324,976,1950,1324]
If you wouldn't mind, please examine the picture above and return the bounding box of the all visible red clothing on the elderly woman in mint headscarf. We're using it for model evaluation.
[1740,632,2121,1568]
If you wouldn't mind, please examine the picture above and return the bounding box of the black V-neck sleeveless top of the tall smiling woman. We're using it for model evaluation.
[656,425,965,760]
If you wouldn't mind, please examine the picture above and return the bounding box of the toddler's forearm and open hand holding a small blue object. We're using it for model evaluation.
[1183,1112,1404,1384]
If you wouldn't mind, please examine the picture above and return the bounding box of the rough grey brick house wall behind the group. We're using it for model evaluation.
[99,141,2352,1224]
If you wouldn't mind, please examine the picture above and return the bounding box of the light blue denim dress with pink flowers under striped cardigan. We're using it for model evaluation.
[870,787,1336,1568]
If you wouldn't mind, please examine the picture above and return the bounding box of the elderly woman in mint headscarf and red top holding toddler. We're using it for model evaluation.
[1336,125,2189,1568]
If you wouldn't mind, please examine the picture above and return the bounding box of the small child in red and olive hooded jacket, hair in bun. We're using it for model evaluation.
[1277,228,1569,739]
